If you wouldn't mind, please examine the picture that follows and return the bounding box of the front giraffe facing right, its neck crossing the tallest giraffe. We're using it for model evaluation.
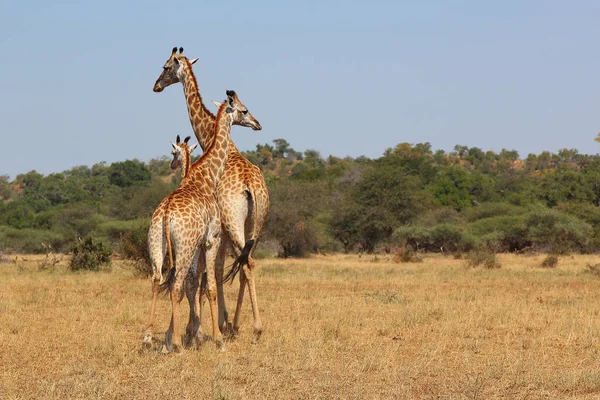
[148,89,261,351]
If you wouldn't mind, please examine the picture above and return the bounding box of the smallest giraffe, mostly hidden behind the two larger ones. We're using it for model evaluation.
[144,135,199,346]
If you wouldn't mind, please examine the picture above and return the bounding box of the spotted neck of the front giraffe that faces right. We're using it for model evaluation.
[192,102,233,188]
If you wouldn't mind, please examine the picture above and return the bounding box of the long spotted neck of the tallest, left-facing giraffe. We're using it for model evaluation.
[180,57,216,151]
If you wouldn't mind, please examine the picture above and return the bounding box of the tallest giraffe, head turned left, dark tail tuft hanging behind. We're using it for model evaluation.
[153,48,269,343]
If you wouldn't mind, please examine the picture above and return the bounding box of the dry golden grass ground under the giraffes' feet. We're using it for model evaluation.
[0,255,600,399]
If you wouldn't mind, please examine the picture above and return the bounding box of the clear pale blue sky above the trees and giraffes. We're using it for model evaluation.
[0,0,600,178]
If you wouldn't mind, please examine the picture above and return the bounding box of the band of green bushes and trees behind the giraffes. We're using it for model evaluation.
[0,139,600,257]
